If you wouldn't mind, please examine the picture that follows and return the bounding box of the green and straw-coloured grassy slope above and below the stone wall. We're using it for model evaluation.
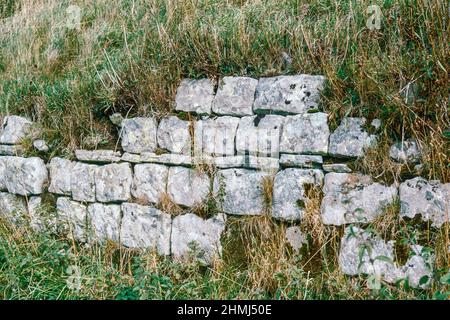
[0,0,450,298]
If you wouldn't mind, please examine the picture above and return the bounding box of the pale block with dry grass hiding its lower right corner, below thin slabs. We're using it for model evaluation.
[272,168,323,221]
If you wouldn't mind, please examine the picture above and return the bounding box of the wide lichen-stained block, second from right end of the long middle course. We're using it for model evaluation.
[321,172,397,225]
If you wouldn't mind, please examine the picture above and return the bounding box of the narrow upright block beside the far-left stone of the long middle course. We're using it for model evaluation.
[48,158,75,196]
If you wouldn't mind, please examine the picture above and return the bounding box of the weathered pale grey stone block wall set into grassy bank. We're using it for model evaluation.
[0,75,450,286]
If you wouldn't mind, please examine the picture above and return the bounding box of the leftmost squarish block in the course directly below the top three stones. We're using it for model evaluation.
[121,118,157,153]
